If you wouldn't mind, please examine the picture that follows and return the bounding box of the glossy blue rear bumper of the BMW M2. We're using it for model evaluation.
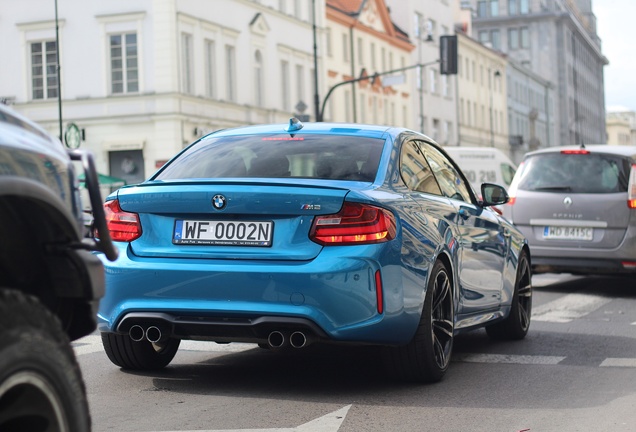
[98,245,424,345]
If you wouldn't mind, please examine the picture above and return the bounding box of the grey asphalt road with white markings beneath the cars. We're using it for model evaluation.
[74,275,636,432]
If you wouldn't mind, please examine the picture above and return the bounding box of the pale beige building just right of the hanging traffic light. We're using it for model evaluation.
[457,31,510,153]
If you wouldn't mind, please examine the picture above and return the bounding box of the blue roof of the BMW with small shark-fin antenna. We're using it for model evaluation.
[207,122,407,138]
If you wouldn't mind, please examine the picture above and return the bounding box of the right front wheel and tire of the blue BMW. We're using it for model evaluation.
[486,251,532,340]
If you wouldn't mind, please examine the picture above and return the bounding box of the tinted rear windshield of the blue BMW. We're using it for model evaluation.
[153,134,384,182]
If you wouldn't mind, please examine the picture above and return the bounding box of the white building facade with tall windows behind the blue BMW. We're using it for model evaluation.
[0,0,325,183]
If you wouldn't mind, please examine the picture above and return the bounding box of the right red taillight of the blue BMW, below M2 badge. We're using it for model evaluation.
[309,203,396,245]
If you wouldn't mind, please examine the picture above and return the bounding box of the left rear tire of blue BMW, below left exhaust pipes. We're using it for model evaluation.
[102,333,181,370]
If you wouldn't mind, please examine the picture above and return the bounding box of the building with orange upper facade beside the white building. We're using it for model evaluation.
[323,0,416,128]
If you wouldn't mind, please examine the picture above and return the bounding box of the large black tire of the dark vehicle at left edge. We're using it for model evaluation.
[0,288,91,432]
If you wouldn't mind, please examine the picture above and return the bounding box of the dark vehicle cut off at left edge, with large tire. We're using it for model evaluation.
[0,104,117,432]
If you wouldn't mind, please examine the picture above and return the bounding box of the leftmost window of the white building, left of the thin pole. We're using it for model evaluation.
[31,41,58,99]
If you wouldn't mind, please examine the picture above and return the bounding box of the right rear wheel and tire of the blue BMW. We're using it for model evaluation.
[384,261,455,383]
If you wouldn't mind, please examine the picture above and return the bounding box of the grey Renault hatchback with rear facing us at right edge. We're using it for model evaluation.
[503,145,636,276]
